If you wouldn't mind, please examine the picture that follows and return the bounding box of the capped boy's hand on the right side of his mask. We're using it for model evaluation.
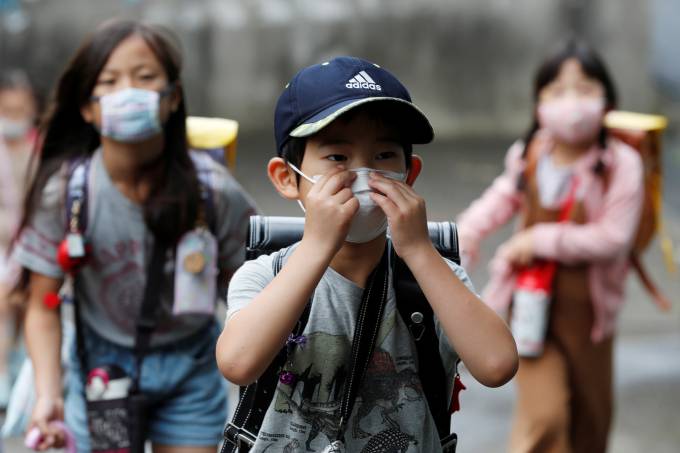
[369,173,432,262]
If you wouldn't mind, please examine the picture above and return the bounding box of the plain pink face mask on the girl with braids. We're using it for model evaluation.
[538,98,604,145]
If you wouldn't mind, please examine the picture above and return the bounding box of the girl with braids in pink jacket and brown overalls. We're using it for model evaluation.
[458,41,643,453]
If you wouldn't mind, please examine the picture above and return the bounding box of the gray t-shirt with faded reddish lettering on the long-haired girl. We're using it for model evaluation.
[14,151,256,347]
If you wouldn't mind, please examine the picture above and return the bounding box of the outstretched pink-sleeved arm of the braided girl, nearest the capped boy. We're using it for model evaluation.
[456,142,524,261]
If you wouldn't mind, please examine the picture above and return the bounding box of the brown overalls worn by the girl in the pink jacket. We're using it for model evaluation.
[510,168,613,453]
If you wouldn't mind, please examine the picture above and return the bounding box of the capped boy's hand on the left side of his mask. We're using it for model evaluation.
[303,167,359,257]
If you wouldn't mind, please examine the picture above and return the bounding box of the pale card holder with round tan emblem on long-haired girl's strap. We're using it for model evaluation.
[172,228,218,315]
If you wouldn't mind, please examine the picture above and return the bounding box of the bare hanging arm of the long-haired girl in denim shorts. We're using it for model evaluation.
[24,273,64,449]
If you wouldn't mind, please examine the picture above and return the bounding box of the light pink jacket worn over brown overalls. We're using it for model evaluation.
[457,132,643,342]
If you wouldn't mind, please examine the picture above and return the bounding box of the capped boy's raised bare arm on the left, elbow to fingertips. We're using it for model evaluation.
[216,169,359,385]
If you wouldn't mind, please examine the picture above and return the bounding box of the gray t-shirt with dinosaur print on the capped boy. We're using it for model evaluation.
[227,246,474,453]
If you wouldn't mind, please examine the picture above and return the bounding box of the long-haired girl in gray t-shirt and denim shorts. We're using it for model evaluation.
[14,20,255,452]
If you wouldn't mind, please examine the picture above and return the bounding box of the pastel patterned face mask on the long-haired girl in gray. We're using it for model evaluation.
[92,87,171,143]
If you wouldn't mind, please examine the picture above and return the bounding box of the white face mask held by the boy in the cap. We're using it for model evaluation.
[288,163,406,244]
